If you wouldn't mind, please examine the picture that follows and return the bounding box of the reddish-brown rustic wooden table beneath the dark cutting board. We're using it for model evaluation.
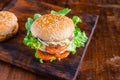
[0,0,120,80]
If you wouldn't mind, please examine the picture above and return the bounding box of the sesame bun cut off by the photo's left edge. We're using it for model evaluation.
[0,11,18,42]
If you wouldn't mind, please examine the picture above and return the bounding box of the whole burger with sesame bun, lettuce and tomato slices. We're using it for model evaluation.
[23,8,87,63]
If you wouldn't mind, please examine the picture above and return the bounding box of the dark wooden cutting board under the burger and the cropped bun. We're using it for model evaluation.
[0,0,98,80]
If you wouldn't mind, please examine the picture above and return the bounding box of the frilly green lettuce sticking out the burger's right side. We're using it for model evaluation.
[68,16,88,54]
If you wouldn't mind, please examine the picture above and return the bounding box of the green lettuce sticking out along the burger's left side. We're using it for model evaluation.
[23,14,42,50]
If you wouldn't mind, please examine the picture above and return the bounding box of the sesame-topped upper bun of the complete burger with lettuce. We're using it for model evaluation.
[31,14,74,42]
